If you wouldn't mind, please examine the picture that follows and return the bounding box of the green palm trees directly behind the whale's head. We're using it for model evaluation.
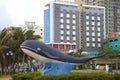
[9,28,41,72]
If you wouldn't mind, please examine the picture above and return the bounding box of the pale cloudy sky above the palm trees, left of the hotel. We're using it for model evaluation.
[0,0,53,29]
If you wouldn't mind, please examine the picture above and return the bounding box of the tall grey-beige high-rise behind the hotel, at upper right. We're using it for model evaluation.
[88,0,120,34]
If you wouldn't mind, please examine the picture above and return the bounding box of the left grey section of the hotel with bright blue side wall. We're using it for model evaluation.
[44,1,79,48]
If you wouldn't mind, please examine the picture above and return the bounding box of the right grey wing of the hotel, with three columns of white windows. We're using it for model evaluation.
[82,5,105,53]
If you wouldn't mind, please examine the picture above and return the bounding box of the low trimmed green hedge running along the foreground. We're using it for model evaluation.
[12,72,120,80]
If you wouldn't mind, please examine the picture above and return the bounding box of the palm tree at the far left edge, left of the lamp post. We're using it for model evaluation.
[0,28,11,73]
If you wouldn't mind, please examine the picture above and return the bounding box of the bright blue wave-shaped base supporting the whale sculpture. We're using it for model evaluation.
[42,62,72,75]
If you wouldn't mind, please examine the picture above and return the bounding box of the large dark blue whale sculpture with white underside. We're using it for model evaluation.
[20,40,105,74]
